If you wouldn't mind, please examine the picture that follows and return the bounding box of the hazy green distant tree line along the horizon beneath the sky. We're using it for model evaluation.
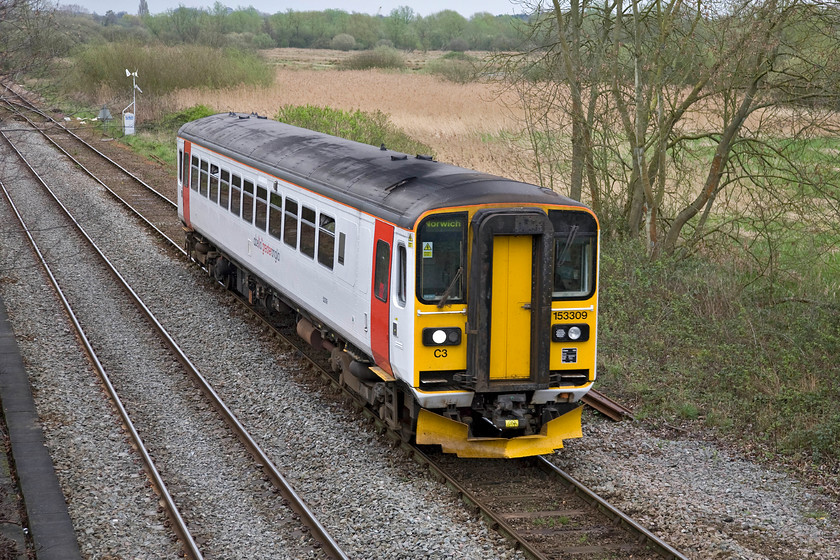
[58,0,527,51]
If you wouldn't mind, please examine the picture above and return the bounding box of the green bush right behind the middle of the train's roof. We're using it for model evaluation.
[274,105,432,155]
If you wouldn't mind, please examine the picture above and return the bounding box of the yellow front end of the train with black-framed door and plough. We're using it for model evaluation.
[412,204,598,458]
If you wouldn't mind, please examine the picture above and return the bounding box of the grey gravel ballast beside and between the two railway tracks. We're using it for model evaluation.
[0,115,840,559]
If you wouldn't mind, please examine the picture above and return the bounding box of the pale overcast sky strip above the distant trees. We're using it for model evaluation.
[72,0,527,18]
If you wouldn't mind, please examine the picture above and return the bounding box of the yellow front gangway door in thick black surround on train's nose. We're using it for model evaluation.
[467,209,554,391]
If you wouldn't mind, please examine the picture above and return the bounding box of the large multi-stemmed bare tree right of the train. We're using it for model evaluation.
[508,0,840,256]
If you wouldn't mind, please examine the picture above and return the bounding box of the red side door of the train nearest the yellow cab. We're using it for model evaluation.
[370,220,394,374]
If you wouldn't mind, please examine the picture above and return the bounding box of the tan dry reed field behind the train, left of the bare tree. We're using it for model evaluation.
[175,49,522,179]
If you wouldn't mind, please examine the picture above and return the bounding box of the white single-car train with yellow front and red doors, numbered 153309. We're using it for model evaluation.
[177,112,600,458]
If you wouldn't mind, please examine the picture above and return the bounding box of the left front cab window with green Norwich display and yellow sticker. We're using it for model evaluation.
[417,212,467,304]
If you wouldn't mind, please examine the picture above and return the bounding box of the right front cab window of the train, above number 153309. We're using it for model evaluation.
[548,210,598,299]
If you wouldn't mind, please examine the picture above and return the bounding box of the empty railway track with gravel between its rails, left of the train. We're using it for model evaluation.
[0,110,346,558]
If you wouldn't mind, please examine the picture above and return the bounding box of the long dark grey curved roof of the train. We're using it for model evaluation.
[178,113,582,229]
